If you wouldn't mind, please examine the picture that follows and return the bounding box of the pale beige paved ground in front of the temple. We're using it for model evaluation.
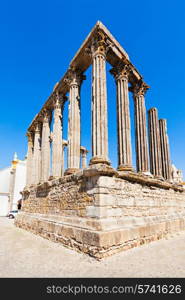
[0,217,185,278]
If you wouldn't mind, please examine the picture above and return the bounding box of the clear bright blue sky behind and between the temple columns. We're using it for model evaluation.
[0,0,185,174]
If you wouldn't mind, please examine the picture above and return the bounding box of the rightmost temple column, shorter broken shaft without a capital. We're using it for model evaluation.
[159,119,171,180]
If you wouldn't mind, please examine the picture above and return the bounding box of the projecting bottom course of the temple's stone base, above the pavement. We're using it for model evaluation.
[15,213,185,259]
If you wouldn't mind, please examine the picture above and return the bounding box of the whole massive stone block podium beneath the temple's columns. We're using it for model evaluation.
[15,165,185,259]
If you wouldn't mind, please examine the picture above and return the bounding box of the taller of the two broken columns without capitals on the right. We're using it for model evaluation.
[148,107,162,177]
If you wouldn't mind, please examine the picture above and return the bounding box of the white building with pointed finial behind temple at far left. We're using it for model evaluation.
[0,153,26,216]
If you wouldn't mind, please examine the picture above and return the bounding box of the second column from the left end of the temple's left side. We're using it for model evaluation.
[32,122,41,184]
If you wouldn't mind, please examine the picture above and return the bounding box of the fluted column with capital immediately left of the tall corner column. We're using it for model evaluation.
[65,70,85,175]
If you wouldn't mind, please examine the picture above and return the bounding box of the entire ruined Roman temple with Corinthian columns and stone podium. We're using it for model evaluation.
[15,21,185,259]
